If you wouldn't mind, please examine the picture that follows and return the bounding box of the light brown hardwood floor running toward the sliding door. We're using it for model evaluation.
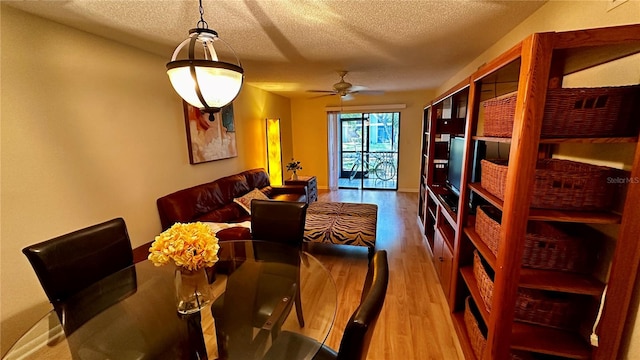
[309,190,464,360]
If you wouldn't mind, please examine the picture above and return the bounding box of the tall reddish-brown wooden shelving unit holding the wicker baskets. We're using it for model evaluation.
[419,25,640,360]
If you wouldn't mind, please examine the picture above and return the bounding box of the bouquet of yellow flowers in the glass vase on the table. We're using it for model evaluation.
[149,222,220,271]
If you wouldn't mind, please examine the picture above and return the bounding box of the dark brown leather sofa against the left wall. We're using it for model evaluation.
[156,168,307,230]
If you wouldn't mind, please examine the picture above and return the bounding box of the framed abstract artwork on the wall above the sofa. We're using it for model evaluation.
[183,101,238,164]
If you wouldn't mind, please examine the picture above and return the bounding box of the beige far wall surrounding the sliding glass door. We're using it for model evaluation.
[292,90,435,192]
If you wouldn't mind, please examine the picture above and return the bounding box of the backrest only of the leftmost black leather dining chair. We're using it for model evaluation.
[22,218,133,303]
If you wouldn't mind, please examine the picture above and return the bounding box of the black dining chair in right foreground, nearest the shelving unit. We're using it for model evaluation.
[264,250,389,360]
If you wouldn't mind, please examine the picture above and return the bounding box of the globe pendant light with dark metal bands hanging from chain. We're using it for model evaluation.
[167,0,244,121]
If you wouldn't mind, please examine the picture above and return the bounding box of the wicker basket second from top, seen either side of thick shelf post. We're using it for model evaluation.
[480,159,623,210]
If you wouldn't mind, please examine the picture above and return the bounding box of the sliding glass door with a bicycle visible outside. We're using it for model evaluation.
[338,112,400,190]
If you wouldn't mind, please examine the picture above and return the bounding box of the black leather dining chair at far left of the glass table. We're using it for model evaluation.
[22,218,136,334]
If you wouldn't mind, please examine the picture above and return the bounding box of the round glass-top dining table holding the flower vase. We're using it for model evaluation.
[3,240,337,360]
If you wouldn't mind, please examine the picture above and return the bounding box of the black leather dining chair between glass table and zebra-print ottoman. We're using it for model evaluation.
[211,200,307,356]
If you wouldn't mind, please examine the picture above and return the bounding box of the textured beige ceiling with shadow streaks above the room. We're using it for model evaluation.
[3,0,545,97]
